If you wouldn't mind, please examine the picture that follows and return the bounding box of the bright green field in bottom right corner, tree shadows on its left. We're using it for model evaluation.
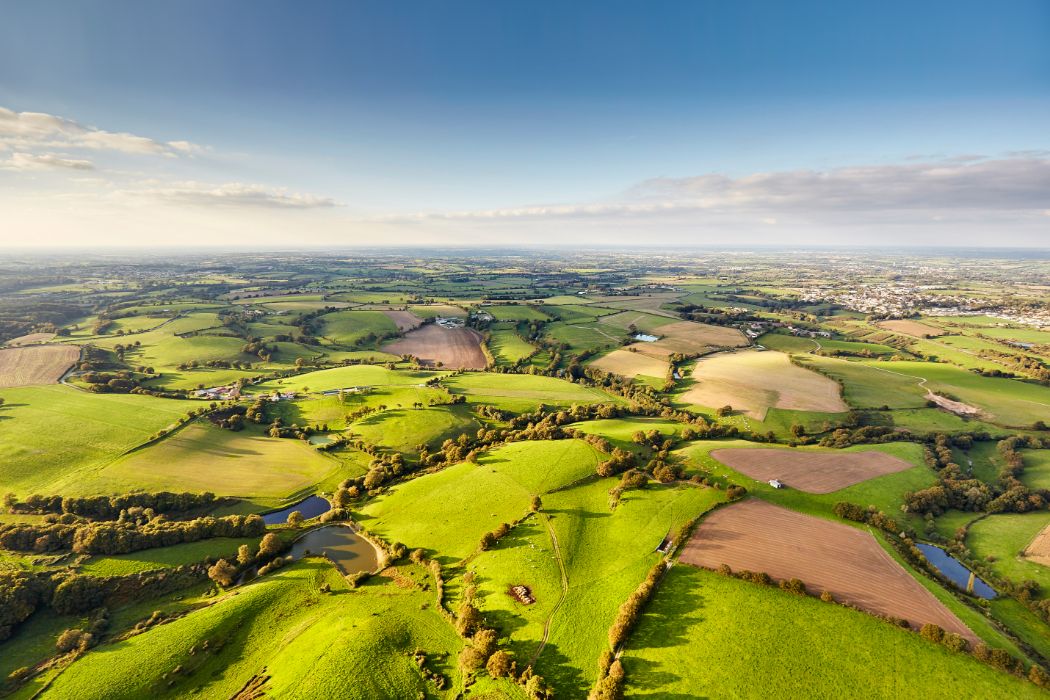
[624,566,1043,699]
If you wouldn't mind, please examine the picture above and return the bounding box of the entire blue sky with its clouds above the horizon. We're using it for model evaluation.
[0,1,1050,245]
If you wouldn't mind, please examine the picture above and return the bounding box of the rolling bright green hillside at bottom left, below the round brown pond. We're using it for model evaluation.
[42,560,461,700]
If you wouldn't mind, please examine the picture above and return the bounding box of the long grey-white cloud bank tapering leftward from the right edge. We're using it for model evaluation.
[377,155,1050,225]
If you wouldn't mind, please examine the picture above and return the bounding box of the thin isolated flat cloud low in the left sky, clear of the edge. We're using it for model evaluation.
[116,182,339,209]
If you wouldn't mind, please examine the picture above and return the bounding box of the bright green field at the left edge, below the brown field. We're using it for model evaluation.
[0,385,202,495]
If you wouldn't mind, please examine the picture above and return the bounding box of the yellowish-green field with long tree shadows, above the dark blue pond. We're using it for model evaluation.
[77,423,340,503]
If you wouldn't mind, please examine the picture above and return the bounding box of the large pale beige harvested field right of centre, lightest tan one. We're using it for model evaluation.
[681,351,848,420]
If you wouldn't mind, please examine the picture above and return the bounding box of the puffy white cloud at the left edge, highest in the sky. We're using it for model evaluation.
[0,107,202,156]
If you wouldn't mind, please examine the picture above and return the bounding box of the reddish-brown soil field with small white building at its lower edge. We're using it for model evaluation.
[711,447,912,493]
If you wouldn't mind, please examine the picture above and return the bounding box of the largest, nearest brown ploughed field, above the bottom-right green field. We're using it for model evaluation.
[681,499,980,643]
